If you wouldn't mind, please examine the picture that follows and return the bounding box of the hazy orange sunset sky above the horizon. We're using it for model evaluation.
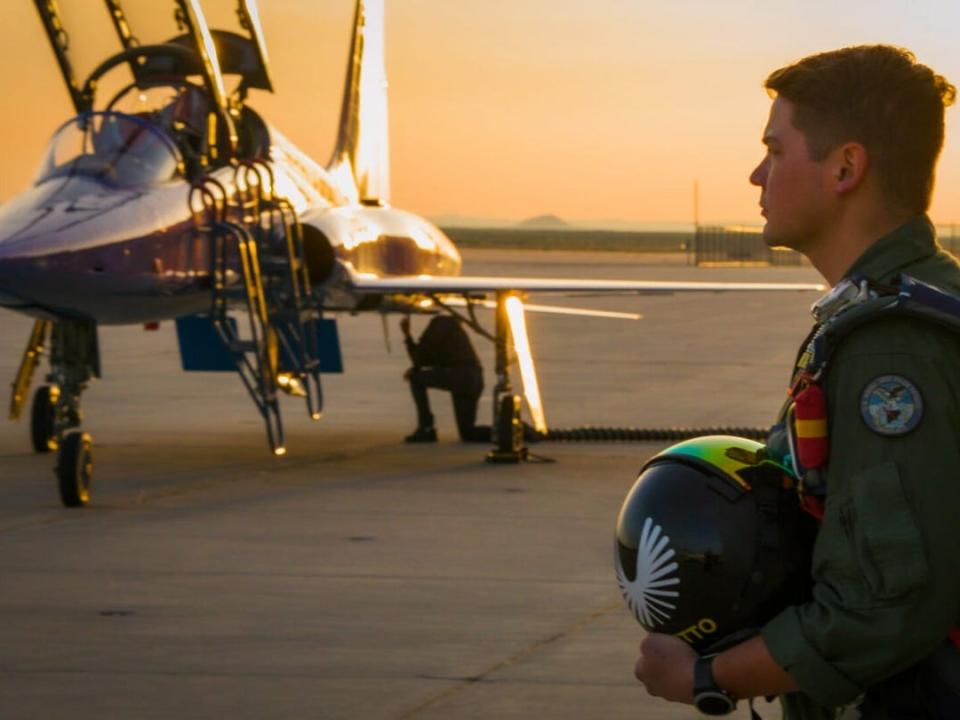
[0,0,960,223]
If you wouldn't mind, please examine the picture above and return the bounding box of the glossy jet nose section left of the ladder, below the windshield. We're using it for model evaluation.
[0,170,208,323]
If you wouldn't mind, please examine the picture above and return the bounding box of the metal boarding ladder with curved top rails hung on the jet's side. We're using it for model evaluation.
[190,161,323,455]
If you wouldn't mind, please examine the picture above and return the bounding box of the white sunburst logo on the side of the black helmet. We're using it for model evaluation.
[617,518,680,628]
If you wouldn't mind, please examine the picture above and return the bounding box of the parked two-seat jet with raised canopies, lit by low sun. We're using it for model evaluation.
[0,0,818,506]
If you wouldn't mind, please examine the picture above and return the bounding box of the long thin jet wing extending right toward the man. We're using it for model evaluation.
[350,273,826,295]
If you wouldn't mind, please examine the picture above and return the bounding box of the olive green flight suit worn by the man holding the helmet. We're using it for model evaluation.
[762,216,960,720]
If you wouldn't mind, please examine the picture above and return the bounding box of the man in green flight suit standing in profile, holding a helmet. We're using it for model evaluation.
[635,46,960,720]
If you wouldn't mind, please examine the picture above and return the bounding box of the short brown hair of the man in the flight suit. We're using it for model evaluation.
[764,45,957,214]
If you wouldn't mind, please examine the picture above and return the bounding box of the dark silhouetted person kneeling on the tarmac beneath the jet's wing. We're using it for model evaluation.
[405,315,490,442]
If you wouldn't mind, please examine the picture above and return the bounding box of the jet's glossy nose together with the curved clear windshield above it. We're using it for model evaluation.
[0,112,207,323]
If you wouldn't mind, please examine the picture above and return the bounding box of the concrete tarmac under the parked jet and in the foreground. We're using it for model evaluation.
[0,250,818,720]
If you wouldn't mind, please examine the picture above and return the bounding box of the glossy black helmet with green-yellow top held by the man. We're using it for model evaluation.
[614,435,816,653]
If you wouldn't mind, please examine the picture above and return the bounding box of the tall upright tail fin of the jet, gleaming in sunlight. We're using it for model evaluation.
[328,0,390,205]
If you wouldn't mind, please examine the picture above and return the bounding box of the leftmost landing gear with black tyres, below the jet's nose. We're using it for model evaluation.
[10,320,100,507]
